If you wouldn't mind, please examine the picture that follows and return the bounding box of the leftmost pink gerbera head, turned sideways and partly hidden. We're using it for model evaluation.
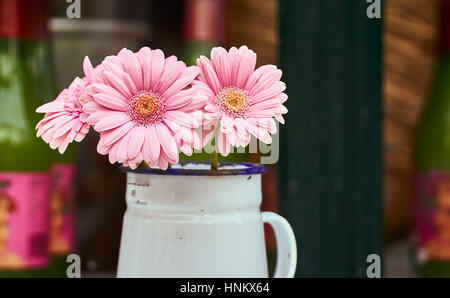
[36,57,96,153]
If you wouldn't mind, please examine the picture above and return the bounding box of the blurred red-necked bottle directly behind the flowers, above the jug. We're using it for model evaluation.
[180,0,249,162]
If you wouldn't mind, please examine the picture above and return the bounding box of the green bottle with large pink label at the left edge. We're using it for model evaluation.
[0,0,50,277]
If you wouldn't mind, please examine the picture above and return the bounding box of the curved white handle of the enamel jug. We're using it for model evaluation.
[261,212,297,278]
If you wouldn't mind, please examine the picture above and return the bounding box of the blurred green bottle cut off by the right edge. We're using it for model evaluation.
[414,0,450,277]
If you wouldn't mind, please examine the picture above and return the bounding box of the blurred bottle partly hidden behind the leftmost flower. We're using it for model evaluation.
[21,0,75,277]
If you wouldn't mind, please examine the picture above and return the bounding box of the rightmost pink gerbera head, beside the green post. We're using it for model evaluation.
[193,46,287,156]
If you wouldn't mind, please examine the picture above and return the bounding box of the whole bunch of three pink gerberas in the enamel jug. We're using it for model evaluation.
[36,46,287,170]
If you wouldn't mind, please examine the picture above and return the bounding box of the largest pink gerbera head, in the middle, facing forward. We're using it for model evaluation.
[83,47,207,169]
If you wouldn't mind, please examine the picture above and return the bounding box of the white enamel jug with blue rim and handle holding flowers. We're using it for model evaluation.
[117,163,297,278]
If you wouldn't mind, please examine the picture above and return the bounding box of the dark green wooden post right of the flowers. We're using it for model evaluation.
[279,0,382,277]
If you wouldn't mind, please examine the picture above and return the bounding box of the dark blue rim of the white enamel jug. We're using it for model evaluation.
[120,162,267,176]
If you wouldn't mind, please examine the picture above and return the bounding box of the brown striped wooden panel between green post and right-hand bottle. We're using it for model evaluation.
[383,0,440,241]
